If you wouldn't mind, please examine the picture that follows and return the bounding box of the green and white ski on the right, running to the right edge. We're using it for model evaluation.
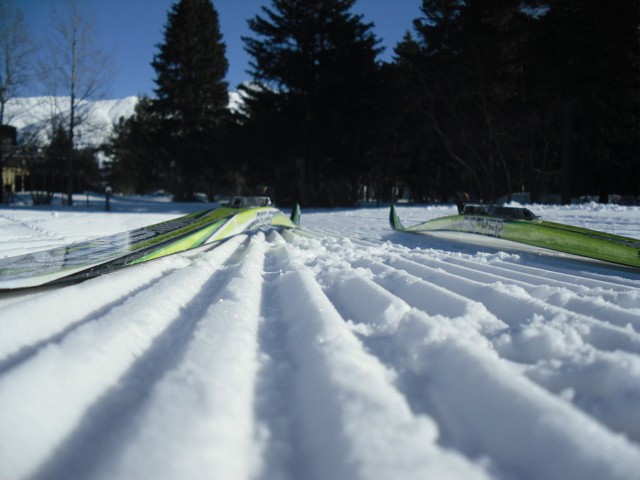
[389,205,640,268]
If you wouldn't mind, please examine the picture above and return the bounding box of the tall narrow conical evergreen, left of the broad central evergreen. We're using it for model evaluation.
[152,0,228,199]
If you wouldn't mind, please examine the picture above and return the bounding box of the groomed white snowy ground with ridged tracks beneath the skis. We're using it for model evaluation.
[0,199,640,480]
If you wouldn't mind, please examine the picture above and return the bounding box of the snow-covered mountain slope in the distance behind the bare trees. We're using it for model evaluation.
[4,92,240,146]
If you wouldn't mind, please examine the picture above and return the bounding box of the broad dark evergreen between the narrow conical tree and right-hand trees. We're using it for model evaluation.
[243,0,380,204]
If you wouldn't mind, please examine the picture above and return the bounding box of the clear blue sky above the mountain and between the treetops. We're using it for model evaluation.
[13,0,422,98]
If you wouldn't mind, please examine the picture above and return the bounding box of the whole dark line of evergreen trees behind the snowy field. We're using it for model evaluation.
[110,0,640,205]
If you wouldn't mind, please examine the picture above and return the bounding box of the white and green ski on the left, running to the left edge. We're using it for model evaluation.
[0,197,300,291]
